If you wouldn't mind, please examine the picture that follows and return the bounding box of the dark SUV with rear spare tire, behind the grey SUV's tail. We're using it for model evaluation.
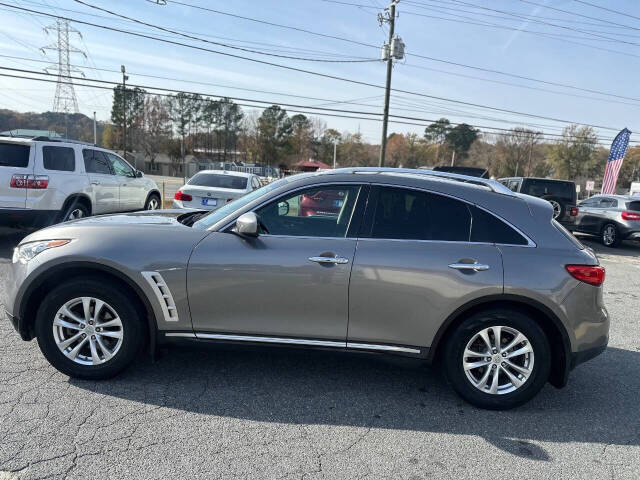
[498,177,578,230]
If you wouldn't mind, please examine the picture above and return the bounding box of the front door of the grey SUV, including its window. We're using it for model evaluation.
[187,184,362,346]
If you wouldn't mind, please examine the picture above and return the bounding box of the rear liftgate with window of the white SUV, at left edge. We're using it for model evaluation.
[0,141,35,208]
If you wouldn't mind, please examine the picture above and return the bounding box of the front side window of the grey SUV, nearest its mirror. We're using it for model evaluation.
[256,185,360,238]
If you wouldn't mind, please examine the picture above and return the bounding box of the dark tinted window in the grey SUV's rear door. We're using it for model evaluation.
[371,187,471,242]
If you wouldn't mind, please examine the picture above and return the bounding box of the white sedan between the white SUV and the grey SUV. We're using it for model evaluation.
[173,170,262,210]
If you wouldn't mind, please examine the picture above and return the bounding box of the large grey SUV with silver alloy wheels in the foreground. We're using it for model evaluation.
[0,168,609,409]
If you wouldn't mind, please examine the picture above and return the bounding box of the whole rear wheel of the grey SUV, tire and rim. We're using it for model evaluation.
[444,309,551,410]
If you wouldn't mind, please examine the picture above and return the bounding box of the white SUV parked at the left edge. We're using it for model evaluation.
[0,137,160,227]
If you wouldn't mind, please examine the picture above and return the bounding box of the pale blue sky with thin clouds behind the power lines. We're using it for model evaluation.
[0,0,640,145]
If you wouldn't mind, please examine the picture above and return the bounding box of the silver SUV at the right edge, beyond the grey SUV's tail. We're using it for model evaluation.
[573,195,640,247]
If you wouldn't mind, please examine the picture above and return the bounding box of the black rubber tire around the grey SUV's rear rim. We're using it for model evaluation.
[444,309,551,410]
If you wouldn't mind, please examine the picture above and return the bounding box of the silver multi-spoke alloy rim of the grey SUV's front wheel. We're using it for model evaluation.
[53,297,124,365]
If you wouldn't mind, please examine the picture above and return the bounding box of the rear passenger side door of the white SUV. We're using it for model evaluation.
[82,148,120,214]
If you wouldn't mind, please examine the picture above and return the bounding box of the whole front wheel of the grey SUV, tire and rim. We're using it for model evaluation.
[35,278,144,380]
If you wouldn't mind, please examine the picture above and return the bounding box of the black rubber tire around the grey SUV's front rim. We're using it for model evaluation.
[35,277,145,380]
